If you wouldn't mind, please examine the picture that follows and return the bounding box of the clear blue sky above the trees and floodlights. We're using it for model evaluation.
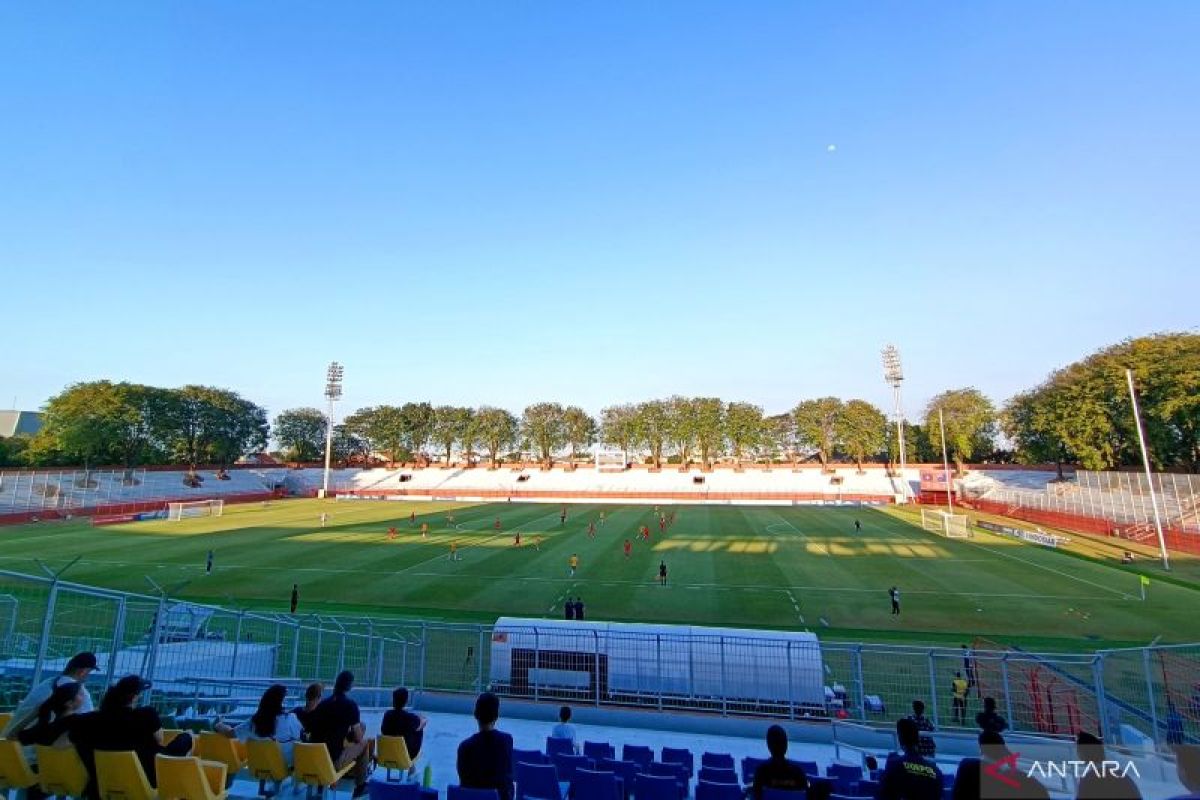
[0,0,1200,422]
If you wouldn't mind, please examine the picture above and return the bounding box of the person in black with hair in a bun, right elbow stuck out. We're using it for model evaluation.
[71,675,192,786]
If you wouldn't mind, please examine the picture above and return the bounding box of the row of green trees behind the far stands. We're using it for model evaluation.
[0,333,1200,471]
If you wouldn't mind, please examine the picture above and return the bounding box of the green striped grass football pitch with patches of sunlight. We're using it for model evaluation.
[0,500,1200,649]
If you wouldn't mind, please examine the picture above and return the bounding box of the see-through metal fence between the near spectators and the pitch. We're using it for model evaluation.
[0,571,1200,748]
